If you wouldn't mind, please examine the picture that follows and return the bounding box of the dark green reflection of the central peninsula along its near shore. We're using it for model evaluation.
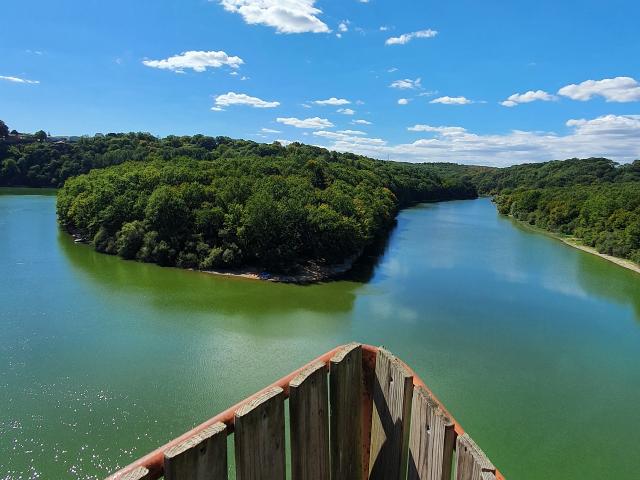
[58,232,360,318]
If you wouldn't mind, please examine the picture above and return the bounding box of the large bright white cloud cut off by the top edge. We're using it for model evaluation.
[220,0,331,33]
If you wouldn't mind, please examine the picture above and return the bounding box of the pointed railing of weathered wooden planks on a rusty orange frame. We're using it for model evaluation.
[108,343,504,480]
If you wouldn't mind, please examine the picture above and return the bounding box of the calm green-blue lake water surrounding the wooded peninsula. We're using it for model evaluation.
[0,190,640,480]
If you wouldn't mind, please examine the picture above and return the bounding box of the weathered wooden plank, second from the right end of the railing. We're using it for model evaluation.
[408,387,455,480]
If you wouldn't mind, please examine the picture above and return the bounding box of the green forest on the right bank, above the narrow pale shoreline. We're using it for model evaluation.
[472,158,640,263]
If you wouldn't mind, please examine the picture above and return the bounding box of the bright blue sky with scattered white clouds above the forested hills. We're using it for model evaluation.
[0,0,640,165]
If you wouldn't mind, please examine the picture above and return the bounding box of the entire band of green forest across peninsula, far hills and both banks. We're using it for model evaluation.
[0,122,640,281]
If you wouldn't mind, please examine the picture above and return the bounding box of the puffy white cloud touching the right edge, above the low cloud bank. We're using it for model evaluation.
[558,77,640,103]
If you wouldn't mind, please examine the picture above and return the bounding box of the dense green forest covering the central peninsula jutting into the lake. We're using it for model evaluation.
[42,134,477,272]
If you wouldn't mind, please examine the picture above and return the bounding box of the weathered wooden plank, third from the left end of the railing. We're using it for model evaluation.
[234,387,285,480]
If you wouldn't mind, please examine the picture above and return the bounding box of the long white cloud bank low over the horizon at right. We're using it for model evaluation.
[314,115,640,166]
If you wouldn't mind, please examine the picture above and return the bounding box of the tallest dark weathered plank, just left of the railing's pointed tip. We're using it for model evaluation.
[329,344,362,480]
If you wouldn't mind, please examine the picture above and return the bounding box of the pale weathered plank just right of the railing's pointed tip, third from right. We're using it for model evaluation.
[369,348,413,480]
